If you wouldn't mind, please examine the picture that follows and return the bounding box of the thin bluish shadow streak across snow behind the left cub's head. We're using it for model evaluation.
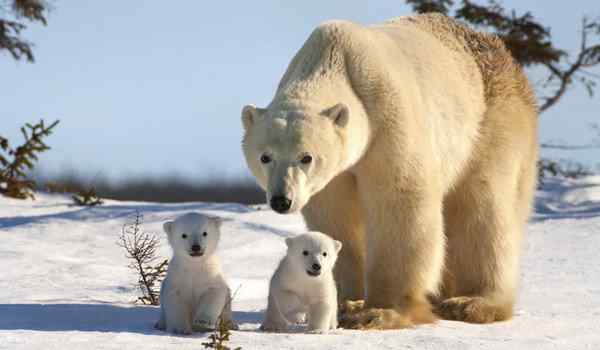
[0,203,256,228]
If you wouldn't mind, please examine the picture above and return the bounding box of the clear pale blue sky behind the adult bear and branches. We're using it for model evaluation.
[0,0,600,178]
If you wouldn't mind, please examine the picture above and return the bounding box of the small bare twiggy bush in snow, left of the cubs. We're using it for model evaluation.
[117,211,169,305]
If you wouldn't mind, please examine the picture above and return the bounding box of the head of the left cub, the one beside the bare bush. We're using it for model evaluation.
[163,213,221,259]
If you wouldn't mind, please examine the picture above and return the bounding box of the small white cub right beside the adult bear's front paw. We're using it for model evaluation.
[261,232,342,333]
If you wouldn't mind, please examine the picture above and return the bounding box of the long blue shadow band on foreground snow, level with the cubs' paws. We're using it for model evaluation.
[0,304,263,336]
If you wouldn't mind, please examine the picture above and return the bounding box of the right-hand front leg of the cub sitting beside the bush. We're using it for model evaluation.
[192,288,230,332]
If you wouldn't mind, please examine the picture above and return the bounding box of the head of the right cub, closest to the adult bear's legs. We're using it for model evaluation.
[285,232,342,277]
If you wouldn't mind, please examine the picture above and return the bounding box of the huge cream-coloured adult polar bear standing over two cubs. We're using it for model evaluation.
[242,15,537,329]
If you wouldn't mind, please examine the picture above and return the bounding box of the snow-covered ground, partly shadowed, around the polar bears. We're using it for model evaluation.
[0,177,600,350]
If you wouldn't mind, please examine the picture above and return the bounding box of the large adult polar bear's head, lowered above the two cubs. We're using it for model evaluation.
[242,103,349,214]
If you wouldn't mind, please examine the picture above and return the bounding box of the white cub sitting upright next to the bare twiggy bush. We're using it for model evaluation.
[156,213,233,334]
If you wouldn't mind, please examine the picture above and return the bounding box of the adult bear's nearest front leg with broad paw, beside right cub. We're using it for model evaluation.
[340,176,444,329]
